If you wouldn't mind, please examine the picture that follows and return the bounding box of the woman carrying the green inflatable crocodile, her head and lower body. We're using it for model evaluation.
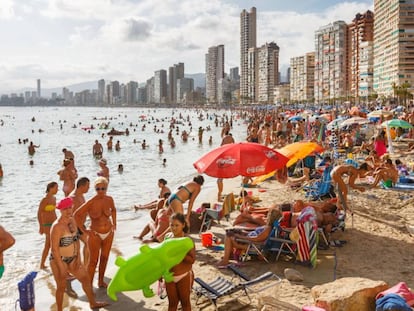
[165,213,195,311]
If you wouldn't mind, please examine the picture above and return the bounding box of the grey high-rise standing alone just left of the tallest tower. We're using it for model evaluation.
[206,45,224,103]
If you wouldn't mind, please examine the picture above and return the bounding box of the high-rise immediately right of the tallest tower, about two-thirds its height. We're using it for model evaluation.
[257,42,279,104]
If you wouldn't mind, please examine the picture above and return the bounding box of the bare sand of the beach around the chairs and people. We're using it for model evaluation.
[22,151,414,310]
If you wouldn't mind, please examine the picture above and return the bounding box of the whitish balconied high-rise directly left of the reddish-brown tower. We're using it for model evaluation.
[315,21,348,103]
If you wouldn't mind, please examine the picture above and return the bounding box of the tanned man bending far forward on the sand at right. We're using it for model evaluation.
[331,163,369,207]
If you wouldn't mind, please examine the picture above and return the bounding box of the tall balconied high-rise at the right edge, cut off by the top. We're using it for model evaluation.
[374,0,414,96]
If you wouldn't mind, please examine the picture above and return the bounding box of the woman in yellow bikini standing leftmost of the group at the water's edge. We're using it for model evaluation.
[37,181,58,269]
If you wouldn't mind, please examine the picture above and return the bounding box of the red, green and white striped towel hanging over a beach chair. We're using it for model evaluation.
[296,206,318,268]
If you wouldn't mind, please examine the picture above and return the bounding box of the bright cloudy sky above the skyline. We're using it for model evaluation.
[0,0,373,93]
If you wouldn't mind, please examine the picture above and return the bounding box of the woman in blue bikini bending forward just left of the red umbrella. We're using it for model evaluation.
[168,175,204,225]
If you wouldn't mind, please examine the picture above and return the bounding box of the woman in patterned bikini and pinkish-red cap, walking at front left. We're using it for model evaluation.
[50,198,108,311]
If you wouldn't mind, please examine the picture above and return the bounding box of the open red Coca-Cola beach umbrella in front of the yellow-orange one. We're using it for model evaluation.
[193,142,289,178]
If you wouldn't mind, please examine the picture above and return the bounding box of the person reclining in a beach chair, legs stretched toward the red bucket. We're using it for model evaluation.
[217,208,282,268]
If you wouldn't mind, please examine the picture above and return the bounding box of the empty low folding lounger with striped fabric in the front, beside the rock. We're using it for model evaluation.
[193,268,281,310]
